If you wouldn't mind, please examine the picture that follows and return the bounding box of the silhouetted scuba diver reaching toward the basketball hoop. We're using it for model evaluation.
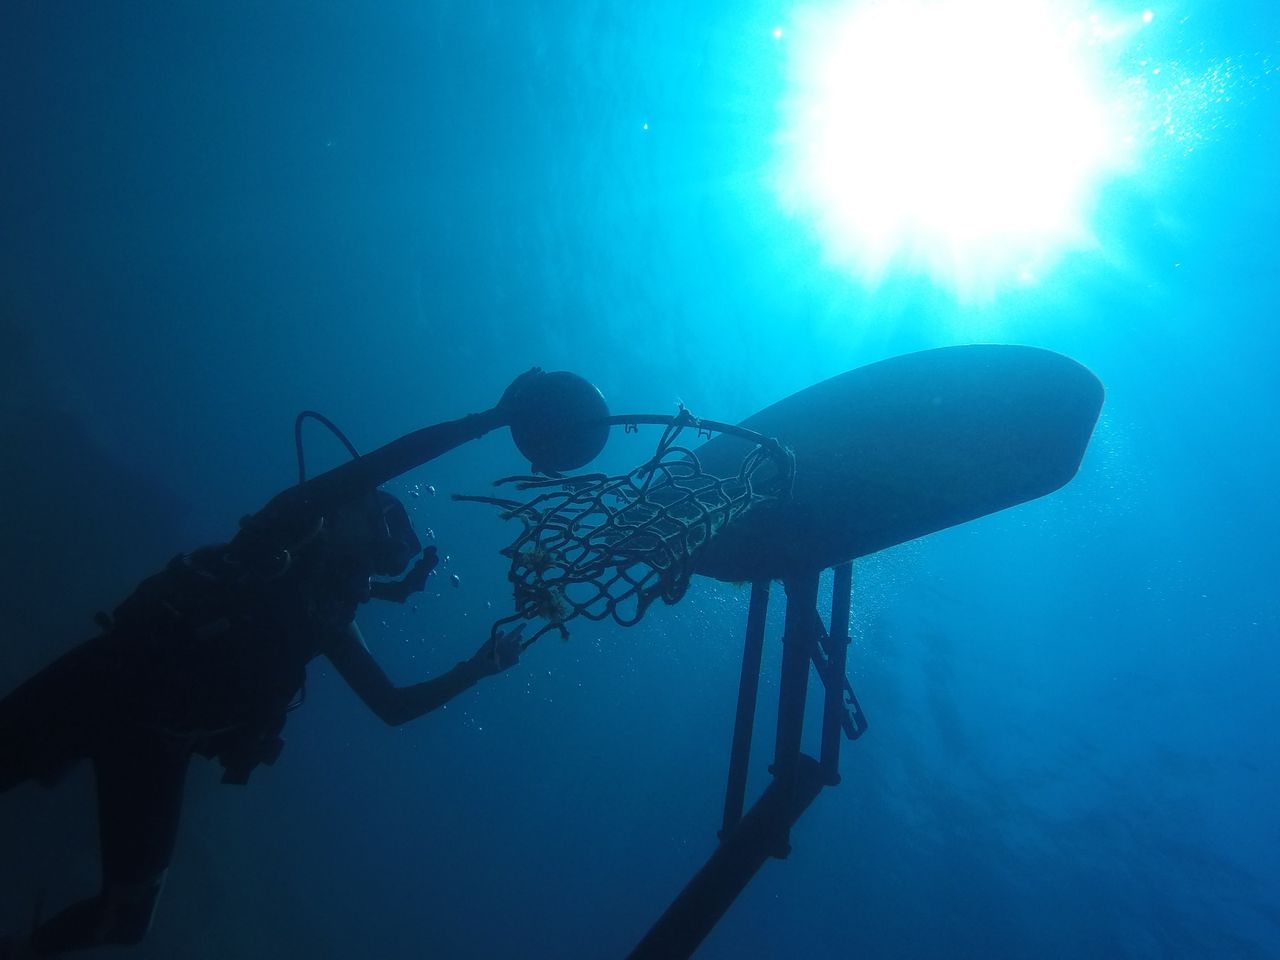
[0,367,548,960]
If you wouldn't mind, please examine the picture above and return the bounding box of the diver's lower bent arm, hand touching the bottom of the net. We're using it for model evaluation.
[325,623,518,727]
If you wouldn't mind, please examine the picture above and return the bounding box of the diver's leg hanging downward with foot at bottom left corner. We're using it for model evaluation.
[32,737,189,956]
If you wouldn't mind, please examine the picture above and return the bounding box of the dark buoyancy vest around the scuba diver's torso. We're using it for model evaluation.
[108,544,367,783]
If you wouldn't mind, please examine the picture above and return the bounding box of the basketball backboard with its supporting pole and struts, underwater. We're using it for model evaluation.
[619,346,1103,960]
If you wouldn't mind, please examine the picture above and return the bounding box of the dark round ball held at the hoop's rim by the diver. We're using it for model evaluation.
[511,370,609,474]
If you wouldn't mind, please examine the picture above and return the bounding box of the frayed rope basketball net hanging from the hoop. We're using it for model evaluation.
[456,407,795,646]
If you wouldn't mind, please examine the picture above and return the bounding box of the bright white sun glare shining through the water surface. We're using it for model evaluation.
[778,0,1152,300]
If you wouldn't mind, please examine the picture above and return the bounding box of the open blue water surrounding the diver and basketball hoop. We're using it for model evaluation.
[0,0,1280,960]
